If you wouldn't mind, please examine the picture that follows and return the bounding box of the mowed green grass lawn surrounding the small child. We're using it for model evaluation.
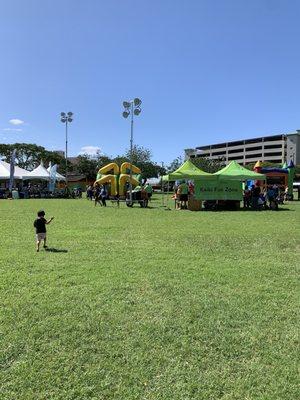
[0,199,300,400]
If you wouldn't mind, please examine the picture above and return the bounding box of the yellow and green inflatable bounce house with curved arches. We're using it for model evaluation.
[94,162,141,197]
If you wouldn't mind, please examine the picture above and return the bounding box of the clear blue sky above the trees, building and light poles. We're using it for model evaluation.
[0,0,300,162]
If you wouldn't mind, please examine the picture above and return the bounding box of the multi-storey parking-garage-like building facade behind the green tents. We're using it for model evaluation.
[185,130,300,165]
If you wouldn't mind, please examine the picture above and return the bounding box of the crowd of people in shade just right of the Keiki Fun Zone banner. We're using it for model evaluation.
[243,185,289,210]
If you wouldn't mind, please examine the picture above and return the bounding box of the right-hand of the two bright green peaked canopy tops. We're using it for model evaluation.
[213,161,266,181]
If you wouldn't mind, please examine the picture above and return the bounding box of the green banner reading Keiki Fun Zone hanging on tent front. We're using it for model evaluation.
[195,181,243,200]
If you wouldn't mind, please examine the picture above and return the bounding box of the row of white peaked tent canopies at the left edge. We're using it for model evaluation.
[0,160,66,181]
